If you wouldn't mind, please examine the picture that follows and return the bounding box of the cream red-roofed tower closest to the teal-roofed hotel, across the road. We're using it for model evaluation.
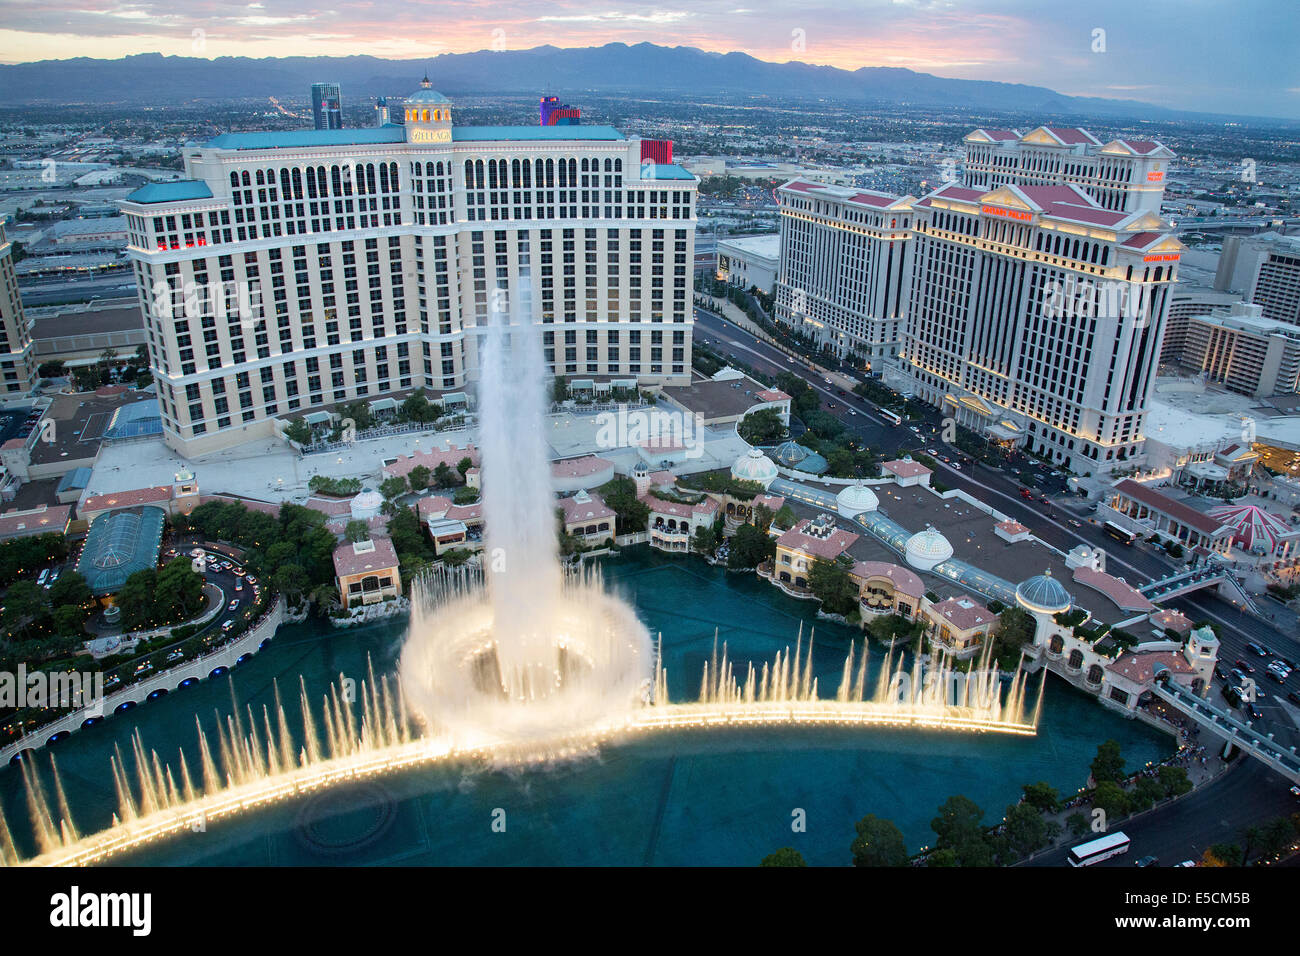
[775,179,915,362]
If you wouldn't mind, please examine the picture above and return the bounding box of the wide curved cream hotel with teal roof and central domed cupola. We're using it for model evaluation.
[122,79,698,457]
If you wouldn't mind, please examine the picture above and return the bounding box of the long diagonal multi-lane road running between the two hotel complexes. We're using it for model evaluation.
[694,308,1300,747]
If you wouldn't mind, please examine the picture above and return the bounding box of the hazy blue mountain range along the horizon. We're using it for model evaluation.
[0,43,1263,118]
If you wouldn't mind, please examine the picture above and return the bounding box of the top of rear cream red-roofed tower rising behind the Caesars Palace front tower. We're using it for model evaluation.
[962,126,1174,212]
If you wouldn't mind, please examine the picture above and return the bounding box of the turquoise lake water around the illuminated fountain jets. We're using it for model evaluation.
[0,548,1173,865]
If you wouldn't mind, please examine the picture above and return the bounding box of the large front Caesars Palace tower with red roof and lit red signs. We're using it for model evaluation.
[904,185,1183,473]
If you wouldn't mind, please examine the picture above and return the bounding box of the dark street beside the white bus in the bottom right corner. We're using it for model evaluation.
[1024,757,1300,866]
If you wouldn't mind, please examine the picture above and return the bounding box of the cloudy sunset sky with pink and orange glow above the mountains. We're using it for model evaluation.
[0,0,1300,117]
